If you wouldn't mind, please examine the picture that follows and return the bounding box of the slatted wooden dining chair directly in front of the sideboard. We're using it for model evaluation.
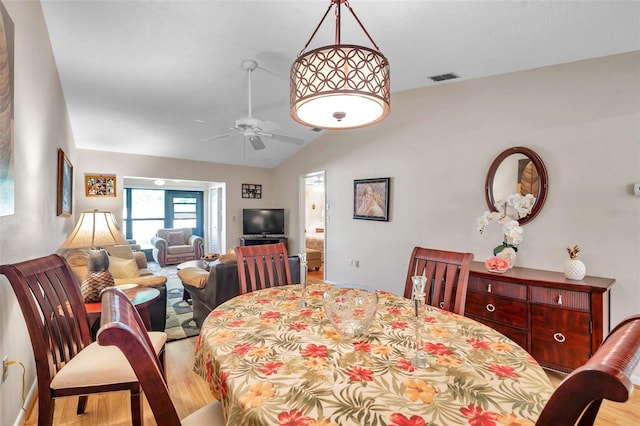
[404,247,473,315]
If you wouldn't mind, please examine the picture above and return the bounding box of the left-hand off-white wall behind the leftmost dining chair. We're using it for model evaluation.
[0,1,75,425]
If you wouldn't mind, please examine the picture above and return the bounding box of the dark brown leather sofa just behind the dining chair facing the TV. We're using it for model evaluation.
[178,255,300,327]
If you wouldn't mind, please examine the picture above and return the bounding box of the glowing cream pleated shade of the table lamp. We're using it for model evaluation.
[60,210,127,249]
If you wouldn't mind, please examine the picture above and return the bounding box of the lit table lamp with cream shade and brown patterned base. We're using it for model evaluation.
[60,210,127,303]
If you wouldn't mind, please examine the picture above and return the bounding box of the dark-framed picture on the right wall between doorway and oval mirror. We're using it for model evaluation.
[353,178,391,222]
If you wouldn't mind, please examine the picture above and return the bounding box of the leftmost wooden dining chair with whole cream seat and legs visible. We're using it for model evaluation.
[0,254,167,426]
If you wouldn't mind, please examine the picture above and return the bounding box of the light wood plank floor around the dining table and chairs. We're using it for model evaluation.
[25,337,640,426]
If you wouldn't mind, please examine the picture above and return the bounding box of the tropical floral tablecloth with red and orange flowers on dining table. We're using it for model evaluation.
[194,284,553,426]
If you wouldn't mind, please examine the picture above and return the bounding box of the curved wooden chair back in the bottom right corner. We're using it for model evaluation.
[536,315,640,426]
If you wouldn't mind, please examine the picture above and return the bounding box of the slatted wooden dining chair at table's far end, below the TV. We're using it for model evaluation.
[235,243,293,294]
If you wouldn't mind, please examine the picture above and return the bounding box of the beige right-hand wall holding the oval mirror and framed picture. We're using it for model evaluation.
[273,52,640,324]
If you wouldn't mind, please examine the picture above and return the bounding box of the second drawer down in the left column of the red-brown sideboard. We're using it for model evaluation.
[465,291,527,329]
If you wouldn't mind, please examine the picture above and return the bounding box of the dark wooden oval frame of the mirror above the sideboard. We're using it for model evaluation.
[484,146,548,225]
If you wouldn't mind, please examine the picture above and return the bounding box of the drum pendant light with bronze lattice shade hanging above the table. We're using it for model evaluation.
[290,0,391,130]
